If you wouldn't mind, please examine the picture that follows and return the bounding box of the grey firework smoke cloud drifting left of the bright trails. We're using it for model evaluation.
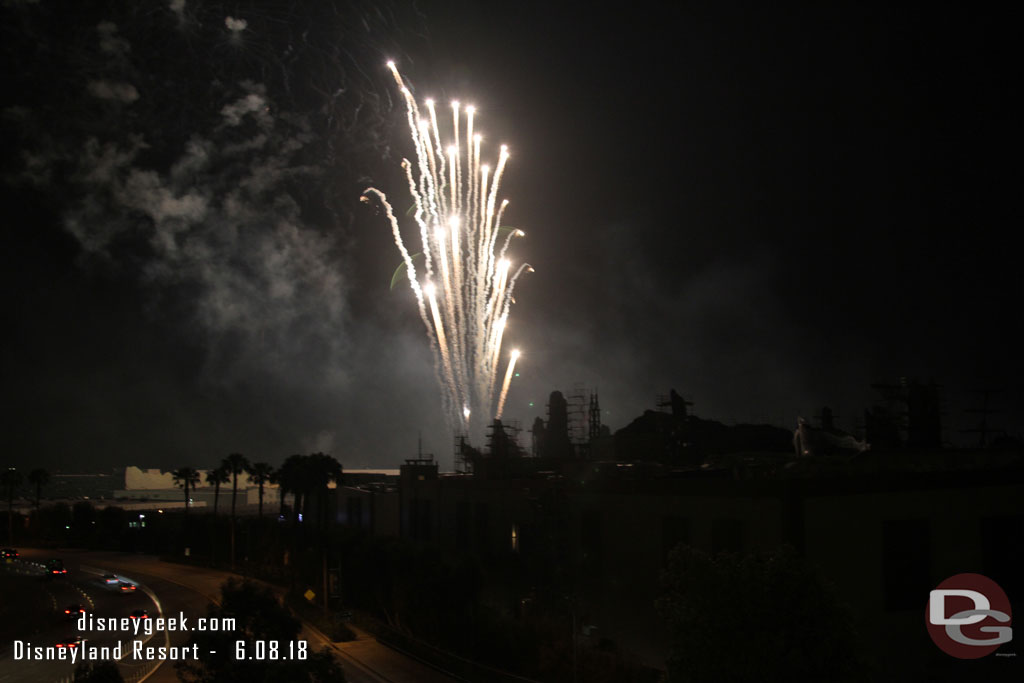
[0,0,440,464]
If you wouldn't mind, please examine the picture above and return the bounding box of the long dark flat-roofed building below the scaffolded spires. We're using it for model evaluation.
[401,444,1024,680]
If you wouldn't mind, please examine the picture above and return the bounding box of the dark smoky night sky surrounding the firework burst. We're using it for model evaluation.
[0,0,1024,470]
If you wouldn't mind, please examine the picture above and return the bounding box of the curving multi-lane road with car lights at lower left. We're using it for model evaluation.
[0,549,458,683]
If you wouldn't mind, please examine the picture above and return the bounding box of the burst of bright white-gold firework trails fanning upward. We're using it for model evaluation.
[361,62,532,435]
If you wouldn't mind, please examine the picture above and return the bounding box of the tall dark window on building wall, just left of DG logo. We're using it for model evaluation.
[882,519,933,609]
